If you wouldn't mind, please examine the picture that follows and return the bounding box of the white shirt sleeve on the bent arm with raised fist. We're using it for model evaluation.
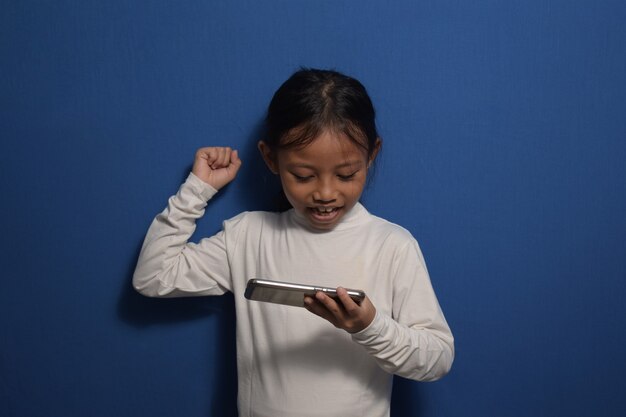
[133,173,231,297]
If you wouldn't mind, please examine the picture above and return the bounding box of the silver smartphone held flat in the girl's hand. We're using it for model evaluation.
[244,279,365,307]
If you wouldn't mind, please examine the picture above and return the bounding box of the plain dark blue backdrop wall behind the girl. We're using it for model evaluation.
[0,0,626,417]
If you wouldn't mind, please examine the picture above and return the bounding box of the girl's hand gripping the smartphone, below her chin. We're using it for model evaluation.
[304,287,376,333]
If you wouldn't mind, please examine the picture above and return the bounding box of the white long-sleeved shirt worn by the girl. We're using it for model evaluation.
[133,174,454,417]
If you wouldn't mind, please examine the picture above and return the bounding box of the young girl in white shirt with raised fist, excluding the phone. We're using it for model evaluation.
[133,70,454,417]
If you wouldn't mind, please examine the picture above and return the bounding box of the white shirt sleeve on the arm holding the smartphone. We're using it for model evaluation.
[352,237,454,381]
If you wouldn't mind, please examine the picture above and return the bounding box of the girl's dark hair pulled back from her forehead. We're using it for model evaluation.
[264,68,379,159]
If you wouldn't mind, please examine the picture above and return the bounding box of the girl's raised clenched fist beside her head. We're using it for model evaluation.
[191,147,241,190]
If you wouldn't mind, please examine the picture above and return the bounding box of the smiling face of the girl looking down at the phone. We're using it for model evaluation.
[259,131,379,230]
